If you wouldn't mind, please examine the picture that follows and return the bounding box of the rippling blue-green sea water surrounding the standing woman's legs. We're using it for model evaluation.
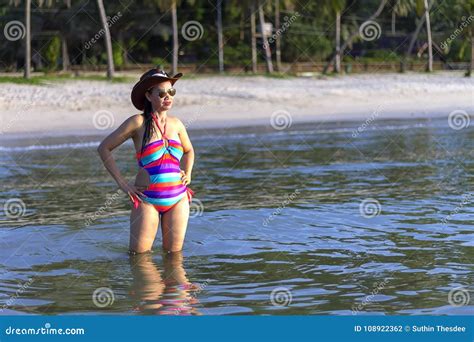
[0,119,474,315]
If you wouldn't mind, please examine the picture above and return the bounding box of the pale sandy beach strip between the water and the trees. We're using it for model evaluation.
[0,73,474,137]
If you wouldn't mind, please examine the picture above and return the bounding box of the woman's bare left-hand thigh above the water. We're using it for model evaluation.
[130,202,160,253]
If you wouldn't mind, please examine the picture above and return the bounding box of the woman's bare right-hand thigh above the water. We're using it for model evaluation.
[161,196,189,252]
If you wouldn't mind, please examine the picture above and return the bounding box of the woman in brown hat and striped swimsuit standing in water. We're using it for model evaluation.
[98,69,194,253]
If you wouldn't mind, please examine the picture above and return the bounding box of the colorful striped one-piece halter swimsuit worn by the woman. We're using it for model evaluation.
[135,114,194,214]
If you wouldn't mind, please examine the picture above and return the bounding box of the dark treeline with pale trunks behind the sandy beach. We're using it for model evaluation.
[0,0,474,77]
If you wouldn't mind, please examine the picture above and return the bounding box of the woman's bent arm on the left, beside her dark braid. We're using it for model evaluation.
[97,114,144,202]
